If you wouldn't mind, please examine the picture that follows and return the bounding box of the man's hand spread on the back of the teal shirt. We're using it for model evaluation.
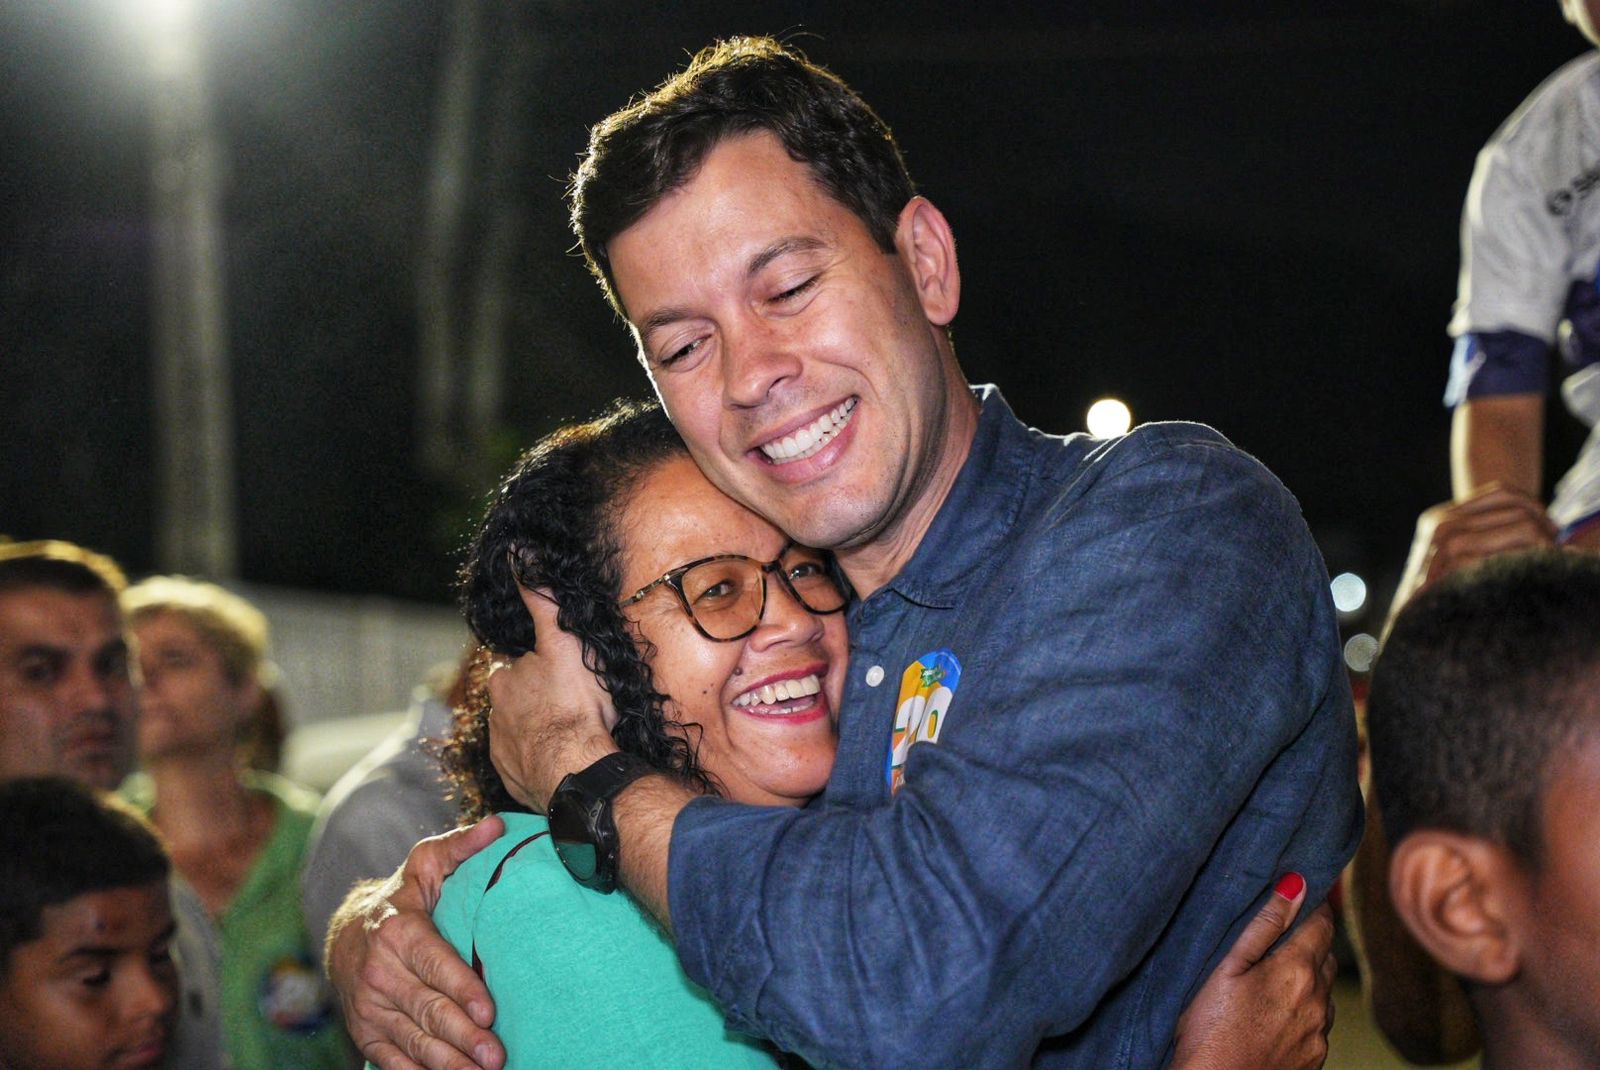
[326,817,506,1070]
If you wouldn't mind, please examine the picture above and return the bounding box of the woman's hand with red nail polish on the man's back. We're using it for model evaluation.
[1173,873,1338,1070]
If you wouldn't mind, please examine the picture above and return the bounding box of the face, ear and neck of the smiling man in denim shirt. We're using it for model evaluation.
[601,133,978,587]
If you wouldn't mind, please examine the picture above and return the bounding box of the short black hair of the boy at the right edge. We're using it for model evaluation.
[1366,550,1600,867]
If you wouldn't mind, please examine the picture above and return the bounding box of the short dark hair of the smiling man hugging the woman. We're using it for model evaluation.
[568,37,917,317]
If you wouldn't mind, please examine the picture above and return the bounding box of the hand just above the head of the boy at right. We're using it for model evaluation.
[1394,483,1555,611]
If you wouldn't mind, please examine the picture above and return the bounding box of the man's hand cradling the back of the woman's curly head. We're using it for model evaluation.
[488,589,616,814]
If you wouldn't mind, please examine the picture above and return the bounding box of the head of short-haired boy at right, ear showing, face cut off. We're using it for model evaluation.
[1368,550,1600,1067]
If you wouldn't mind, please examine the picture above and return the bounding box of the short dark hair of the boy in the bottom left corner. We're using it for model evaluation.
[0,777,170,974]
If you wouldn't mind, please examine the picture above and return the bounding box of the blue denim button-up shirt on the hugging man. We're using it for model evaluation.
[669,387,1362,1070]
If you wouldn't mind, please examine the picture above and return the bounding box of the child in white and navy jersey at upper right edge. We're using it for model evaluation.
[1445,0,1600,549]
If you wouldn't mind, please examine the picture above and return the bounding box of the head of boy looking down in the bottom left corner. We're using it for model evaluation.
[0,777,178,1070]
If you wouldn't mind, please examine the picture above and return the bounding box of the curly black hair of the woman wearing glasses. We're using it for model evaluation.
[440,401,715,820]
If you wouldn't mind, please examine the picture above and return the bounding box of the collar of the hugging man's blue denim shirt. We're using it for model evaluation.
[886,385,1032,609]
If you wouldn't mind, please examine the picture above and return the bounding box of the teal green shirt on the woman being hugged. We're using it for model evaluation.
[434,814,776,1070]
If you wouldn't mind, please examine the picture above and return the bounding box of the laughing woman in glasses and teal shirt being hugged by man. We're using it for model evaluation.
[434,403,1331,1070]
